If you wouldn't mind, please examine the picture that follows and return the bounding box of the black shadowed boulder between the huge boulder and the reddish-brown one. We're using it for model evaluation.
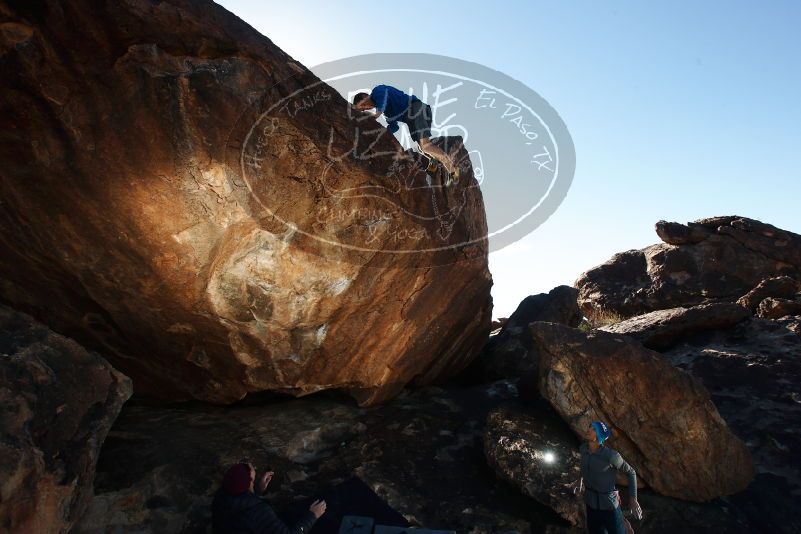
[468,286,582,382]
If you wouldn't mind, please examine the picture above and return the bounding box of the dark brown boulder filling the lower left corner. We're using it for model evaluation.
[0,306,131,534]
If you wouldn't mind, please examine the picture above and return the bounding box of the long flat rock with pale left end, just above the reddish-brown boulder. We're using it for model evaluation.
[599,302,751,350]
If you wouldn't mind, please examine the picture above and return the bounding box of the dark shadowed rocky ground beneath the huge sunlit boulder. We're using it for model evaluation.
[74,381,568,534]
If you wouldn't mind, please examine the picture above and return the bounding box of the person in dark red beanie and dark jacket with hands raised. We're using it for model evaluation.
[211,460,326,534]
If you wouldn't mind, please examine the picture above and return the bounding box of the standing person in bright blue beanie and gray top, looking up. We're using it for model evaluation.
[573,421,642,534]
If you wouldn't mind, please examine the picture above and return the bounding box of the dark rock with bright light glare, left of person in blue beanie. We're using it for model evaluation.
[484,405,585,527]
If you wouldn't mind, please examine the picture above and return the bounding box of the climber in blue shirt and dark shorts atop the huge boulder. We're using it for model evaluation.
[353,85,460,185]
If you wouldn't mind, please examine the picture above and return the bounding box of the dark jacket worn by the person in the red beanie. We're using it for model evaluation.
[211,490,317,534]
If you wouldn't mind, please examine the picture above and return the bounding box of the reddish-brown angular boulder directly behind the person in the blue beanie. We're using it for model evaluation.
[531,322,754,501]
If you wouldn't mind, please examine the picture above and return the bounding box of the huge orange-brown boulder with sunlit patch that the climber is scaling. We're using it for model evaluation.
[0,0,492,404]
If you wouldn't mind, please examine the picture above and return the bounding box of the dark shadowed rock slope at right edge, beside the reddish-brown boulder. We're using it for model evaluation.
[664,317,801,532]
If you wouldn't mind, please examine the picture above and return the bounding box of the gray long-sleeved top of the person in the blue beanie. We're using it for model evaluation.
[579,443,637,510]
